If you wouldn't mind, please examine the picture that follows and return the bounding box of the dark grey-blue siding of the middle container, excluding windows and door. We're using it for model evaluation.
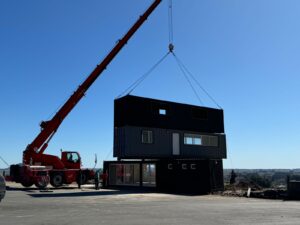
[114,126,226,159]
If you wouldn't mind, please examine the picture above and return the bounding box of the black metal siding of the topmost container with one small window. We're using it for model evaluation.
[114,95,224,133]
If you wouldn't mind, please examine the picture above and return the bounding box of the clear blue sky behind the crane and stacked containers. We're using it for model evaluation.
[0,0,300,168]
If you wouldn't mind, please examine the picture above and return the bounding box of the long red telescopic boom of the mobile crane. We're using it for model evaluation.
[23,0,162,164]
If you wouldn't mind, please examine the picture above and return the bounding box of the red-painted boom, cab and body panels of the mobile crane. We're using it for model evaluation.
[14,0,162,188]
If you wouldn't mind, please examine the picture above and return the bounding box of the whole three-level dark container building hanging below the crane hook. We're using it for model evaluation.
[104,95,226,193]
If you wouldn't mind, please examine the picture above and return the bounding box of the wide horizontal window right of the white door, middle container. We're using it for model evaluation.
[184,134,219,147]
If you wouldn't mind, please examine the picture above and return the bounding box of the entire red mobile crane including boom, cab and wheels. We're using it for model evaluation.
[11,0,162,187]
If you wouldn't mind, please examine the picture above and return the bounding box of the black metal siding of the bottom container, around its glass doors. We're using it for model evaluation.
[103,160,224,194]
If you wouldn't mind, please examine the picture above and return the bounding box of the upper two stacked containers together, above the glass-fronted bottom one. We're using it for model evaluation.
[114,95,226,159]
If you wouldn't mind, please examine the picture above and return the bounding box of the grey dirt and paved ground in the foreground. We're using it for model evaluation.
[0,184,300,225]
